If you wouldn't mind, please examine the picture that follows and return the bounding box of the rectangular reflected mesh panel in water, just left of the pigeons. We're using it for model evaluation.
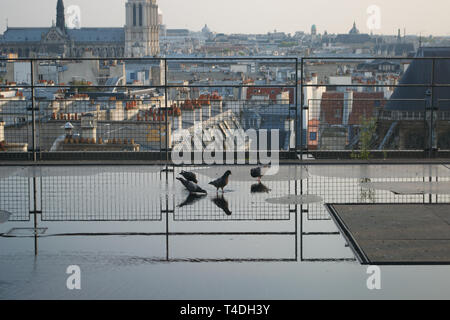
[41,170,162,221]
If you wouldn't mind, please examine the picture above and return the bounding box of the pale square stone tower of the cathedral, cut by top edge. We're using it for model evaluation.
[125,0,159,57]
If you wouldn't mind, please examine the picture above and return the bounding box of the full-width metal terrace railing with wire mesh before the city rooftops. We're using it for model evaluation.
[0,57,450,163]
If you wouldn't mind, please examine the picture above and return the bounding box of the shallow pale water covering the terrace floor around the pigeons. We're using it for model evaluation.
[0,165,450,299]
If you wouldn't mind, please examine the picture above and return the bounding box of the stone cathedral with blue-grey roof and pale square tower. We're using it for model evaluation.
[0,0,159,58]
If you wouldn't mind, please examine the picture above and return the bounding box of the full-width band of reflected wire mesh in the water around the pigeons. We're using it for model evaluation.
[0,165,450,222]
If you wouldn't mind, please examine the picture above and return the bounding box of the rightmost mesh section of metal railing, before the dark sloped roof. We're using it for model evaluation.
[300,56,450,160]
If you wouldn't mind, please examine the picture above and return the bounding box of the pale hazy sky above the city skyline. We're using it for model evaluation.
[0,0,450,35]
